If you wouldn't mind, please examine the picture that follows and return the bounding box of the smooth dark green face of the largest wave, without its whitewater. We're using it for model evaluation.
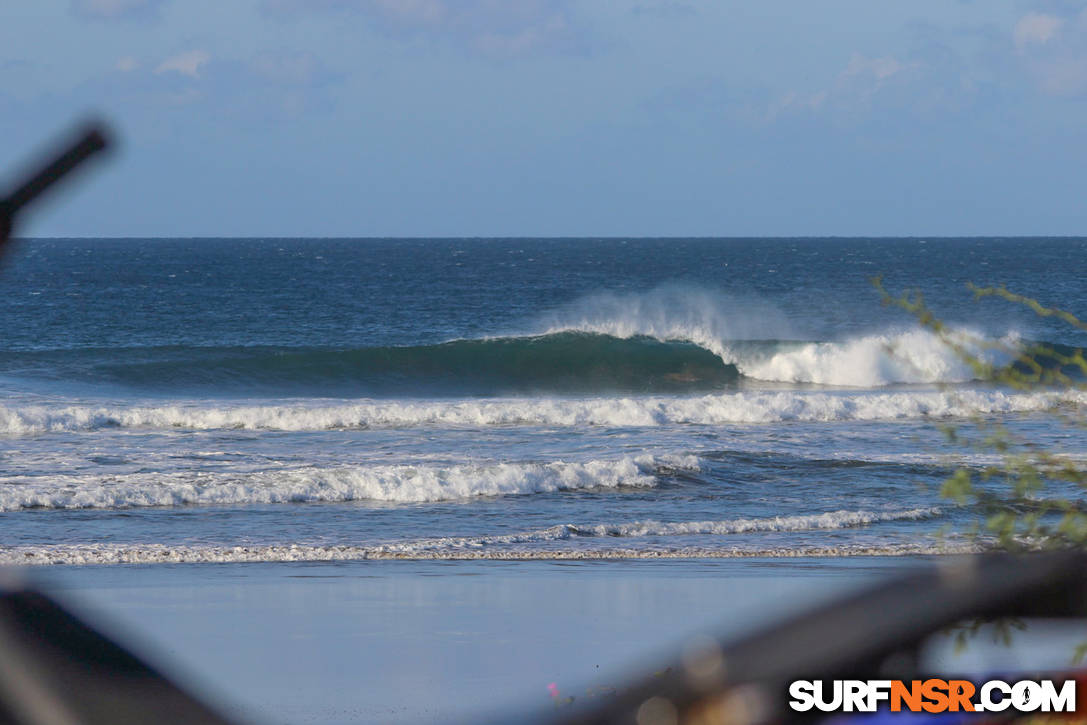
[0,332,739,396]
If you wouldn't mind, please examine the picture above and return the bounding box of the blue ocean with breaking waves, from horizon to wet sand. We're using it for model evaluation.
[0,238,1087,564]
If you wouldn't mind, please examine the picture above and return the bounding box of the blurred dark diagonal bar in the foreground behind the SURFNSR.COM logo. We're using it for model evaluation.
[558,552,1087,725]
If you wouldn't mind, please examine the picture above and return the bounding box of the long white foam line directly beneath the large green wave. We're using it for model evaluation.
[0,389,1087,435]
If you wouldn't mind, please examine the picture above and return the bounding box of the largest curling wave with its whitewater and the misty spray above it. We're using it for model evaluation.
[0,285,1082,397]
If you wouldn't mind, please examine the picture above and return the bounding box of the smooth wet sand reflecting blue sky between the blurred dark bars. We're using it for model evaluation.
[24,557,922,724]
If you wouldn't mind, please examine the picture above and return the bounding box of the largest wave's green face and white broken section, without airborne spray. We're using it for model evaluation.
[0,326,1072,397]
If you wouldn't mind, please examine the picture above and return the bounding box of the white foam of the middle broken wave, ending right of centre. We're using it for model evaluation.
[0,455,698,511]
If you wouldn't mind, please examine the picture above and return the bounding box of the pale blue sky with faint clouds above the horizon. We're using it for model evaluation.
[0,0,1087,236]
